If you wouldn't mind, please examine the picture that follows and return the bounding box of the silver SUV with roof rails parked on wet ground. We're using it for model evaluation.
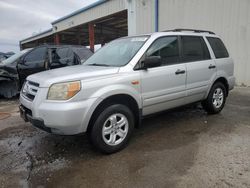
[20,29,235,153]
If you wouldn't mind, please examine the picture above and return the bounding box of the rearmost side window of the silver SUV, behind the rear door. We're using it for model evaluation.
[207,37,229,58]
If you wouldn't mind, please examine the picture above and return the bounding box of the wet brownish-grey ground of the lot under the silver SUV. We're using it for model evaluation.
[0,88,250,188]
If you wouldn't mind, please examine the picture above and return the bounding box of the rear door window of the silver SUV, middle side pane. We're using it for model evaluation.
[181,36,211,62]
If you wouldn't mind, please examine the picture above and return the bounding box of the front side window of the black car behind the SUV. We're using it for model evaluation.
[24,47,47,63]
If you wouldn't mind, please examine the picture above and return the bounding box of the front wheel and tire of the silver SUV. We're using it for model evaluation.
[89,104,135,154]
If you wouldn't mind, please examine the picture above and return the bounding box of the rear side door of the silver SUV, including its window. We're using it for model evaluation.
[181,36,216,103]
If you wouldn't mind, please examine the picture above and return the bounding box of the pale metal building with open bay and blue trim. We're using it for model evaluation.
[20,0,250,86]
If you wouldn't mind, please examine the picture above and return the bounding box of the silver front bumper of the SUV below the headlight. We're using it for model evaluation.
[20,89,99,135]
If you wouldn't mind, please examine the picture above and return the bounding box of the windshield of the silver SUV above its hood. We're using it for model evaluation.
[83,36,148,67]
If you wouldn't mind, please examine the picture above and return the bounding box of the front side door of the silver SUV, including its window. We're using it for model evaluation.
[140,36,186,115]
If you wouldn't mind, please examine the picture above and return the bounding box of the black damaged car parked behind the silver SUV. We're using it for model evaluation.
[0,45,93,98]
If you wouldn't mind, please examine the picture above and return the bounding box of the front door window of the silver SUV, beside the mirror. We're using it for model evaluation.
[146,36,180,66]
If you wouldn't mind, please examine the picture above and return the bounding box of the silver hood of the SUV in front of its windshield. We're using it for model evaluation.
[27,65,119,87]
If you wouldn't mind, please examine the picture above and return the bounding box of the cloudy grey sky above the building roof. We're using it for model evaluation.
[0,0,98,52]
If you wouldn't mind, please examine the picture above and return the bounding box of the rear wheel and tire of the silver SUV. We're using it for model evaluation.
[201,82,227,114]
